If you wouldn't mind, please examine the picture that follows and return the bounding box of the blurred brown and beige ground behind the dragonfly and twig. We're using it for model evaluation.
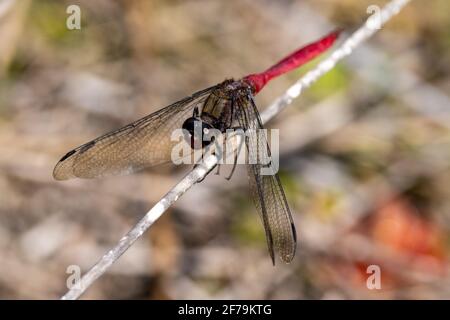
[0,0,450,299]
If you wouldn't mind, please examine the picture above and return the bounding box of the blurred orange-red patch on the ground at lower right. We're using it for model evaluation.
[339,198,447,293]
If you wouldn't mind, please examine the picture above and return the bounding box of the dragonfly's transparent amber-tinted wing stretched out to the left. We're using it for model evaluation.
[53,86,216,180]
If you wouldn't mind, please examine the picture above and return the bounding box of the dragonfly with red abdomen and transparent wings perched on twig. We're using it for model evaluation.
[53,31,339,265]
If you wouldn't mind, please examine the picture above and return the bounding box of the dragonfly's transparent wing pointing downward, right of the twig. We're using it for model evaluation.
[236,95,297,264]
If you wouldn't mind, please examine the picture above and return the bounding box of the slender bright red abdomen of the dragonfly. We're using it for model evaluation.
[243,30,340,94]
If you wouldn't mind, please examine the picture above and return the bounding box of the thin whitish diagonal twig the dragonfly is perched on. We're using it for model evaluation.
[62,0,410,299]
